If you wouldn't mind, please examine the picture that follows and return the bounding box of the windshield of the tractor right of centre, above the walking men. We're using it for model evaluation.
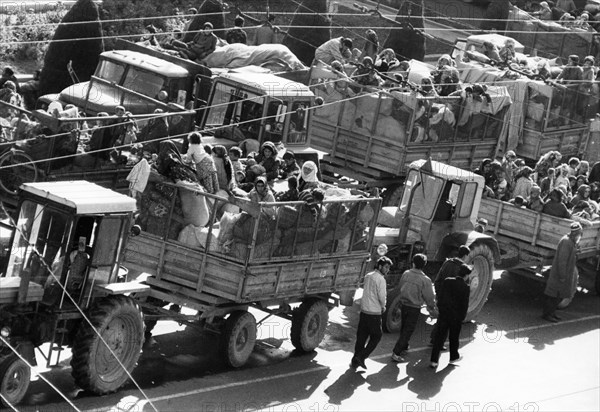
[400,170,445,220]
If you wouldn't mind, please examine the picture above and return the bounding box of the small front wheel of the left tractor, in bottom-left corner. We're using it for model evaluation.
[0,355,31,410]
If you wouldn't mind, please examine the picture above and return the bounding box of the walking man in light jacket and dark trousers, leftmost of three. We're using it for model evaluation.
[350,256,392,369]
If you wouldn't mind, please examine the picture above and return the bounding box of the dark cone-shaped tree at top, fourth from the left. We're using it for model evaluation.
[383,0,425,61]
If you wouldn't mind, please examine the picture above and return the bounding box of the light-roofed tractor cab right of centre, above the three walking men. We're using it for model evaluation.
[396,160,485,259]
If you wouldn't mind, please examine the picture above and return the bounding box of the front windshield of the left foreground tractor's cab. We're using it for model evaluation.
[6,201,70,286]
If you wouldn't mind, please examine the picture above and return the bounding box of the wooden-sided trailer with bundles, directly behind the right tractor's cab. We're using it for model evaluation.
[308,60,511,206]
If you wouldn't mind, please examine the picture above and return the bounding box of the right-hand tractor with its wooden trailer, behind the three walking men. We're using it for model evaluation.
[374,159,600,332]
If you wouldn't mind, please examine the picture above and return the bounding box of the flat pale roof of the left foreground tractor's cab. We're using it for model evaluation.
[20,180,136,215]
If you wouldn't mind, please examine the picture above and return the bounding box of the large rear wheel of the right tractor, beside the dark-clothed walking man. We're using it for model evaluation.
[465,245,494,320]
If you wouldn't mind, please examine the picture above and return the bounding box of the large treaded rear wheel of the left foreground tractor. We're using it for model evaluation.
[71,296,144,395]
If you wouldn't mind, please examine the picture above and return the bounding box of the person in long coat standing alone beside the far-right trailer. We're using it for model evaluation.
[542,222,583,323]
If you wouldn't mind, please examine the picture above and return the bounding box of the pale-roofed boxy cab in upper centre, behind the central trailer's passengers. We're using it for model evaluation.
[202,72,314,150]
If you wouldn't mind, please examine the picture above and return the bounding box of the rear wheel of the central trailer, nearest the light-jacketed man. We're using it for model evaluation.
[290,300,329,352]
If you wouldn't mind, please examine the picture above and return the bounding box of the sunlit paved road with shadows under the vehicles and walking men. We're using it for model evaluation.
[17,272,600,412]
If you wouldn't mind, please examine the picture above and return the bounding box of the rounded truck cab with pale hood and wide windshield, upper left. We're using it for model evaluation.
[36,40,212,115]
